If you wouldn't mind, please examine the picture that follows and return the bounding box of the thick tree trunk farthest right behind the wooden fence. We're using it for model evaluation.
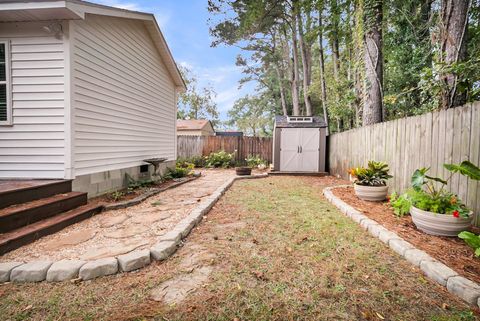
[440,0,470,109]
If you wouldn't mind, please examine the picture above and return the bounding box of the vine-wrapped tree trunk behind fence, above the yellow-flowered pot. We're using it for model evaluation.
[363,0,384,125]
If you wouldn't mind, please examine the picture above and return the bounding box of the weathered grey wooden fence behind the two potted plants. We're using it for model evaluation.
[329,102,480,225]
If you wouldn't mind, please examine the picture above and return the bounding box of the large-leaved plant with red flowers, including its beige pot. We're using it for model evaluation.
[409,161,480,236]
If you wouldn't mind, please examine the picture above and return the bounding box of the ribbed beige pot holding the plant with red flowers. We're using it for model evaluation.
[410,206,473,236]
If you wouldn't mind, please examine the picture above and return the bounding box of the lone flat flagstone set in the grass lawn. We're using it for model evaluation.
[150,266,212,304]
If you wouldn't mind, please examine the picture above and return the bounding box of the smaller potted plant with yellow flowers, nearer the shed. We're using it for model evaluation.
[349,161,393,202]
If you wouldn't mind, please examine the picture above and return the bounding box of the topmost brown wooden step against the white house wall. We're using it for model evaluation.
[0,179,72,208]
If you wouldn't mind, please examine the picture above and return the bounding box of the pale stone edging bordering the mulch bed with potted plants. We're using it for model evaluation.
[323,185,480,308]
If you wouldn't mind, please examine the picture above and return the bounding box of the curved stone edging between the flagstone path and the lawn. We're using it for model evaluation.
[0,173,268,283]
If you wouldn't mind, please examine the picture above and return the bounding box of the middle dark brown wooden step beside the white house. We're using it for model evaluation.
[0,192,87,233]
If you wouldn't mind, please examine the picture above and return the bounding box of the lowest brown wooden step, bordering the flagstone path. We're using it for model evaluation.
[0,204,103,255]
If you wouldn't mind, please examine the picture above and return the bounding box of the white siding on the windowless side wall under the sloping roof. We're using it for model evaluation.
[70,15,176,176]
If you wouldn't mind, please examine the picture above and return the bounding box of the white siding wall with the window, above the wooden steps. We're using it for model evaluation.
[0,22,65,178]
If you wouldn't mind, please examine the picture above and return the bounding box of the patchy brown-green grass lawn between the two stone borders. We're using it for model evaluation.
[0,177,477,321]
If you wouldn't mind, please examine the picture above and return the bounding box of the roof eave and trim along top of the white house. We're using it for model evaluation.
[0,0,186,90]
